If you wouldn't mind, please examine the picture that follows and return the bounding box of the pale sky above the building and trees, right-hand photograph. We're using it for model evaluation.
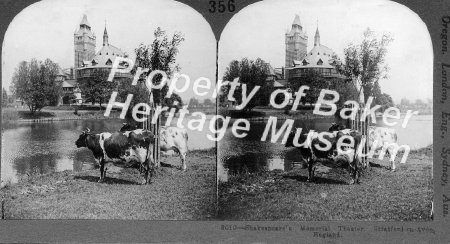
[219,0,433,103]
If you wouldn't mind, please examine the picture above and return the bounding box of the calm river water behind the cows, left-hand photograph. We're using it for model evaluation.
[1,118,215,184]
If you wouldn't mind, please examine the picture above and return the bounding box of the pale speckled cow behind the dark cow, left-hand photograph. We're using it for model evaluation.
[120,123,188,171]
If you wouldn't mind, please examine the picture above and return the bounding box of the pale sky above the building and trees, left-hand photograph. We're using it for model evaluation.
[1,0,216,102]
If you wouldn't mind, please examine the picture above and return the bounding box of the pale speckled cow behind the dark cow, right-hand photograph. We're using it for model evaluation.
[328,123,397,171]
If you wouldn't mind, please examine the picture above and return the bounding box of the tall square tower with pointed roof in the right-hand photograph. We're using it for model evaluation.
[285,14,308,67]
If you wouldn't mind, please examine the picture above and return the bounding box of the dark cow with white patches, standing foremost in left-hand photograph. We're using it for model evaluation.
[75,128,154,184]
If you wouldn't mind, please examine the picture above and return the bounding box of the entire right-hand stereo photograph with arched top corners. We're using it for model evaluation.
[217,0,433,221]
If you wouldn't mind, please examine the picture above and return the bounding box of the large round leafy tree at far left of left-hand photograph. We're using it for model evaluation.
[10,59,62,113]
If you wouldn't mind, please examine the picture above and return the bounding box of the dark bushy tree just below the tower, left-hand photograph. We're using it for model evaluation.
[79,69,118,110]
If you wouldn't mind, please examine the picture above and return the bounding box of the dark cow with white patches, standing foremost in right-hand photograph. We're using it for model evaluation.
[285,131,361,184]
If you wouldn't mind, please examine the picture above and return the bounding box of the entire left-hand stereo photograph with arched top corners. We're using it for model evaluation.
[0,0,217,220]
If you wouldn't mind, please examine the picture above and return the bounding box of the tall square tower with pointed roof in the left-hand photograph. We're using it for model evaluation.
[73,14,95,69]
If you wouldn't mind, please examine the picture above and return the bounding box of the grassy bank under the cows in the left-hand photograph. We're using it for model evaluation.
[0,149,216,220]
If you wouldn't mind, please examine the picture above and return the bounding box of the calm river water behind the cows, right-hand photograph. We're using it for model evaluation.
[217,115,433,181]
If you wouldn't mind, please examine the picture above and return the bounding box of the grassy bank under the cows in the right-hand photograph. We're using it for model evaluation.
[219,146,433,221]
